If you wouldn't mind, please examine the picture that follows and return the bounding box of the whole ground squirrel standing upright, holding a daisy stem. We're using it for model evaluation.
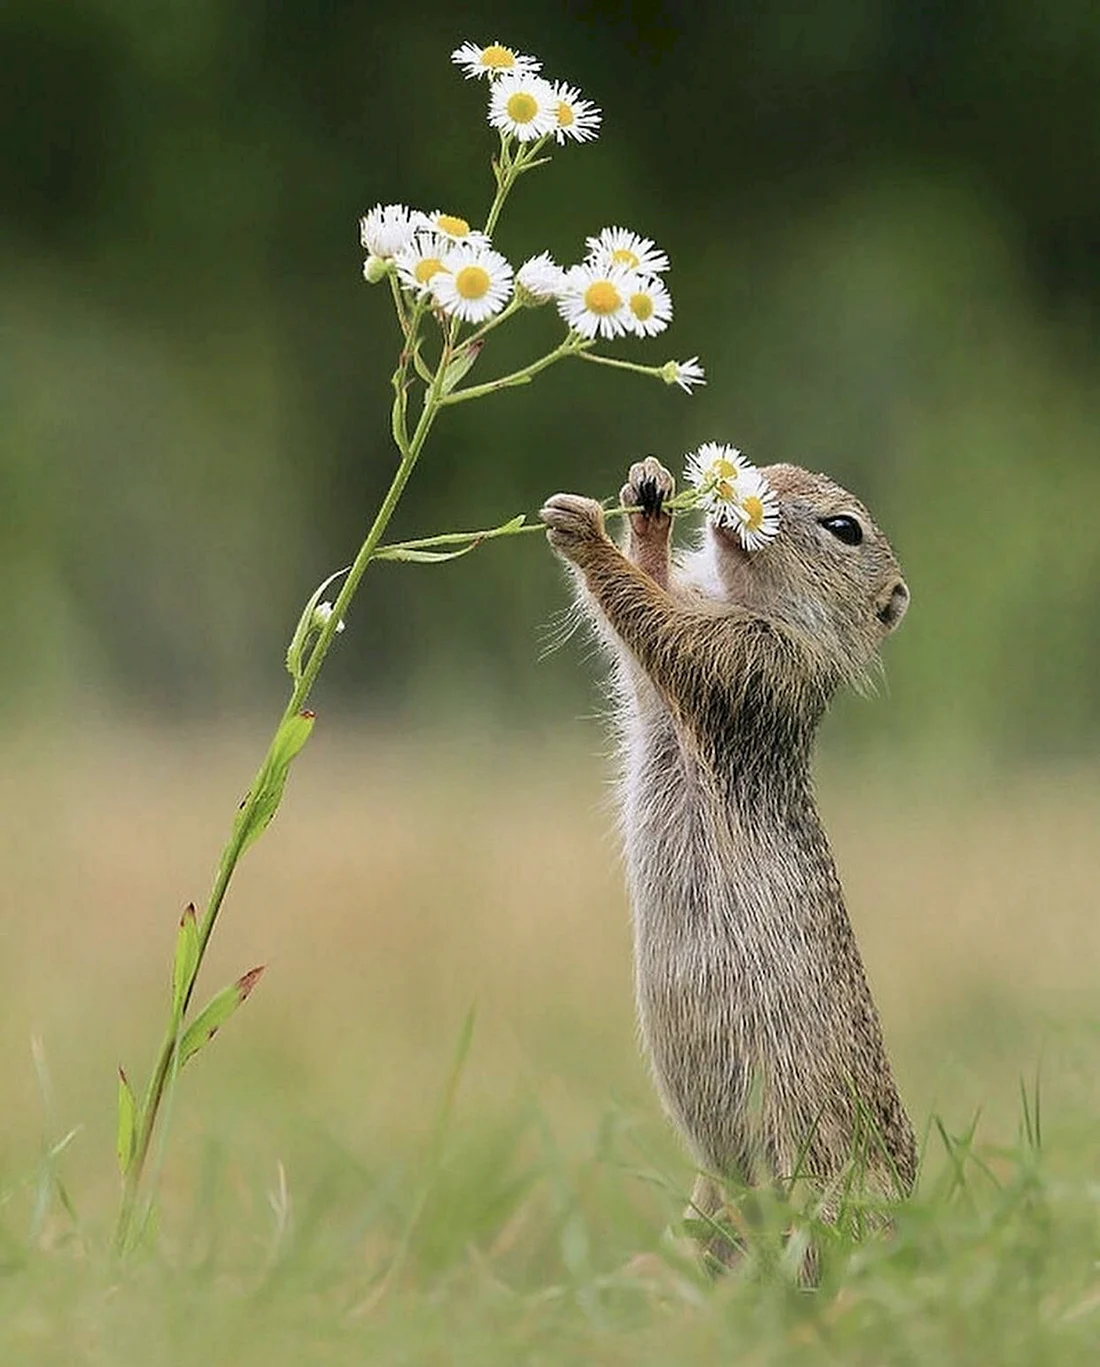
[541,457,917,1257]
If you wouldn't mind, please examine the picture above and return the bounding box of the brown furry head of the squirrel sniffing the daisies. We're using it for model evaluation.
[706,465,909,682]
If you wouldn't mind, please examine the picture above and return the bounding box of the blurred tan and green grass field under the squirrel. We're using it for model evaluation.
[0,723,1100,1367]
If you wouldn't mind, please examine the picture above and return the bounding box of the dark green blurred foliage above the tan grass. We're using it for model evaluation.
[0,0,1100,752]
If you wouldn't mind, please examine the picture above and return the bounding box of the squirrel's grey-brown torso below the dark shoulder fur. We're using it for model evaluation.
[609,700,916,1189]
